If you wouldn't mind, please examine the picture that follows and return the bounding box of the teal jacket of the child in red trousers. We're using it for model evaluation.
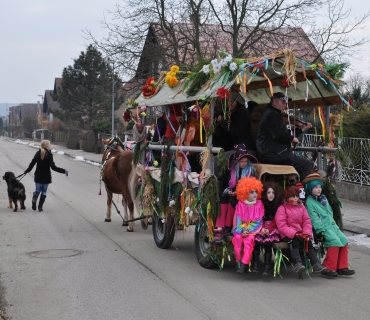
[306,196,349,248]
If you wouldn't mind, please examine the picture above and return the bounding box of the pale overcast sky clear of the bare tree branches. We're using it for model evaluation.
[0,0,370,103]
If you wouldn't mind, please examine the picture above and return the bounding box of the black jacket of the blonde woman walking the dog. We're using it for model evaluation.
[24,149,66,184]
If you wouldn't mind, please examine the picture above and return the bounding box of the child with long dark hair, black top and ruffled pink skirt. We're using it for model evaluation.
[252,182,283,276]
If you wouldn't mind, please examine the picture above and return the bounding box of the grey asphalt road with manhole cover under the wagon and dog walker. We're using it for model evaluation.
[0,139,370,320]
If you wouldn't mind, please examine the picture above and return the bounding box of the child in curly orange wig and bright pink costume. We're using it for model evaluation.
[232,177,265,274]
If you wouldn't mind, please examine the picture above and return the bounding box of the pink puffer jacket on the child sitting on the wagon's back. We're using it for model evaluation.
[275,203,312,239]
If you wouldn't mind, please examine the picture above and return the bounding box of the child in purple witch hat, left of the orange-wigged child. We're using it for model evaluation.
[213,144,257,243]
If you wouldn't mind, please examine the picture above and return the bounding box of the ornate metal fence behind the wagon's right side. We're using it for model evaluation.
[300,134,370,186]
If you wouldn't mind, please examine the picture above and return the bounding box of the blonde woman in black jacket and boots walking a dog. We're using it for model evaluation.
[24,140,68,212]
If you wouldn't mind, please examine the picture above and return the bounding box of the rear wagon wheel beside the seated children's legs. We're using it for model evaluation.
[194,221,217,269]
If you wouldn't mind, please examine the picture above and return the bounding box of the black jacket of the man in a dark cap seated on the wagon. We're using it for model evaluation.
[256,105,302,165]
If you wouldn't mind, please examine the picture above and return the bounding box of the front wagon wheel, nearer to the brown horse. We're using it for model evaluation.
[152,214,176,249]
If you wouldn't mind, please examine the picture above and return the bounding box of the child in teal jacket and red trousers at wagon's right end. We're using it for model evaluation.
[303,173,355,277]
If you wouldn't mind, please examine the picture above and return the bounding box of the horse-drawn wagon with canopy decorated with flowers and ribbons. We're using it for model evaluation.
[125,49,348,268]
